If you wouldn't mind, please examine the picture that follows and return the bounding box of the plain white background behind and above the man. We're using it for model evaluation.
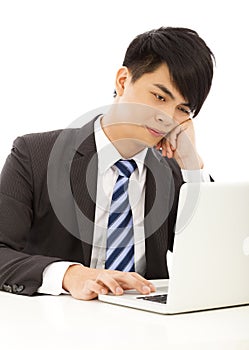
[0,0,249,181]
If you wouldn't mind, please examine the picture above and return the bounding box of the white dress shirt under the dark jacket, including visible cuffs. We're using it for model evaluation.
[38,117,210,295]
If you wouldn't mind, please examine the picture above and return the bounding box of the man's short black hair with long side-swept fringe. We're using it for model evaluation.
[118,27,215,116]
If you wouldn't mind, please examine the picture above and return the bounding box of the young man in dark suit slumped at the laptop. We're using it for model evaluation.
[0,28,213,300]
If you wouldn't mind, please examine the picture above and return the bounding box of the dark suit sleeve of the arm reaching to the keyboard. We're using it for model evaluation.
[0,137,61,295]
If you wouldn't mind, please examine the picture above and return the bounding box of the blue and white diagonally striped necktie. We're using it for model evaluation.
[105,160,137,271]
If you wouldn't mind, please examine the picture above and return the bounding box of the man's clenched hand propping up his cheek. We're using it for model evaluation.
[156,119,203,170]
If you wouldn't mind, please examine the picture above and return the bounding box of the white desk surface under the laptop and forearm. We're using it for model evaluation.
[0,292,249,350]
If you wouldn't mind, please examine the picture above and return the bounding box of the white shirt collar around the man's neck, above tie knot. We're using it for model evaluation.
[94,116,148,177]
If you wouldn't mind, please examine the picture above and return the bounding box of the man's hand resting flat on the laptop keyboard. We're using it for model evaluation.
[62,265,156,300]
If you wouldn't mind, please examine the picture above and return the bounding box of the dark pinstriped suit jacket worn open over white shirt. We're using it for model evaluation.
[0,117,183,295]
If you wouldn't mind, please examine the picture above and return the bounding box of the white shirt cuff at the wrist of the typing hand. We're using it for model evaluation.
[37,261,82,295]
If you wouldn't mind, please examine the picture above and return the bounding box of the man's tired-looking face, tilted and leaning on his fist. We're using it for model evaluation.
[108,64,191,147]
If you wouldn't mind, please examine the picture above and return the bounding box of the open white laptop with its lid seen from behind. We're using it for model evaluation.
[99,182,249,314]
